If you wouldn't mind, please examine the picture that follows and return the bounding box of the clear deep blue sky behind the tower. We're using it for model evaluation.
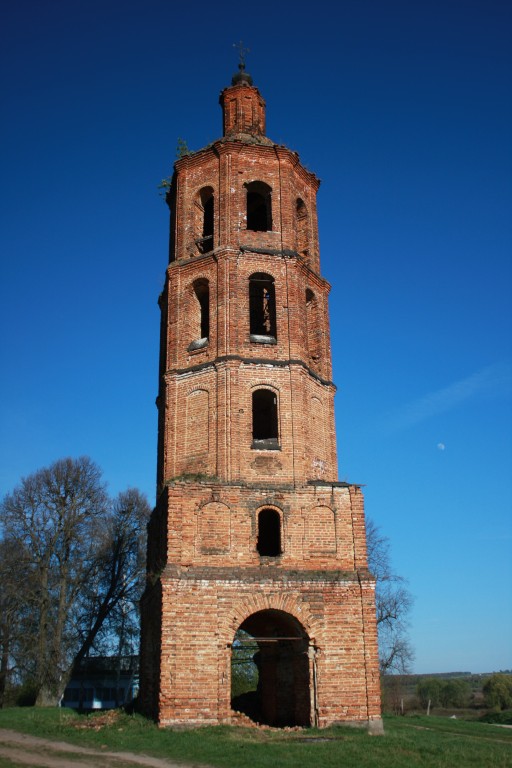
[0,0,512,672]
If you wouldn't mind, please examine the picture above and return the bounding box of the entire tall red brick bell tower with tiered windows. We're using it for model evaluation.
[141,63,381,731]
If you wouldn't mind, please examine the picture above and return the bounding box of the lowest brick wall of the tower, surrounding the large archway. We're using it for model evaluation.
[155,572,380,727]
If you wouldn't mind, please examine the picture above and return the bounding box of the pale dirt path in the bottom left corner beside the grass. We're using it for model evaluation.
[0,728,206,768]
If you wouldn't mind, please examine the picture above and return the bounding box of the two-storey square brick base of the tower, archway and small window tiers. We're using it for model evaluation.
[140,481,380,726]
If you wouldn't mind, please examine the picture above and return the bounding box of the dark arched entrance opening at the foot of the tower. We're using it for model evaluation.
[231,609,314,728]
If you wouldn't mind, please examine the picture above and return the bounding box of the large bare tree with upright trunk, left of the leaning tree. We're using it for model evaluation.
[1,457,108,705]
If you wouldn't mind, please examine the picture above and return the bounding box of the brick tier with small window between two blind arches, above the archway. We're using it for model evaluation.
[154,480,367,571]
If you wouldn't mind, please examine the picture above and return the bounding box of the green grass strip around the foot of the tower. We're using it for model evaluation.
[0,708,512,768]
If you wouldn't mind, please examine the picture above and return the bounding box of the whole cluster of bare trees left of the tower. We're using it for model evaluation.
[0,457,150,706]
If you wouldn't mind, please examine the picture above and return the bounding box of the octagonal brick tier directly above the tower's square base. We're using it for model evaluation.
[158,360,336,482]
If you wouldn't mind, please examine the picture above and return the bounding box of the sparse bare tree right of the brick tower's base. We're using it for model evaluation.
[366,520,414,674]
